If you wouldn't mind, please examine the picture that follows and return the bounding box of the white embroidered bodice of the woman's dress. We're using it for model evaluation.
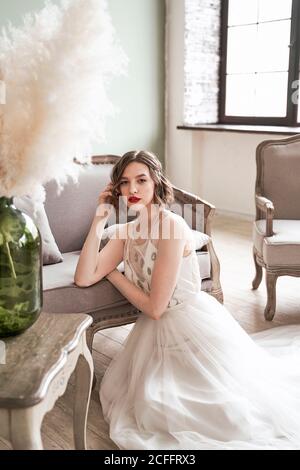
[124,210,201,308]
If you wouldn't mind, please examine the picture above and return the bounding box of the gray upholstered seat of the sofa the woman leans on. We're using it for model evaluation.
[43,251,210,318]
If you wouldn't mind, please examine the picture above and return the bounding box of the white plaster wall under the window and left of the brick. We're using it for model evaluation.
[166,0,283,215]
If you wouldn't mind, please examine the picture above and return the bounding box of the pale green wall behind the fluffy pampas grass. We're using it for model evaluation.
[0,0,165,161]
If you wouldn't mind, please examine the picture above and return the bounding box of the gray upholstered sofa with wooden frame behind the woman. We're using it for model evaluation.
[43,155,223,350]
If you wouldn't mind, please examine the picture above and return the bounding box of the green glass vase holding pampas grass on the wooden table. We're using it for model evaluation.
[0,197,43,337]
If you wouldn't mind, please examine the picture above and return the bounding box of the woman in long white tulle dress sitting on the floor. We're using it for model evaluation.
[75,152,300,449]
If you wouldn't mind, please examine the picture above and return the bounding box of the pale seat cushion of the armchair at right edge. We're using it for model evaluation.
[253,219,300,266]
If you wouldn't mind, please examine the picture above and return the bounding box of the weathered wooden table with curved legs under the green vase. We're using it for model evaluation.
[0,313,94,450]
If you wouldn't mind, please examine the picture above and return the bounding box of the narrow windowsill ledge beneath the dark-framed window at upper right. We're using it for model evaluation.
[177,124,300,135]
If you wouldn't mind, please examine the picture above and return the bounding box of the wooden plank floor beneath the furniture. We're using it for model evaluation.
[0,215,300,450]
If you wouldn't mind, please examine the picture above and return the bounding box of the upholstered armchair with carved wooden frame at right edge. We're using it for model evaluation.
[252,135,300,320]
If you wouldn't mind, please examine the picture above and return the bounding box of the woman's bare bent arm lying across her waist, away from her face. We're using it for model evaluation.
[107,220,186,320]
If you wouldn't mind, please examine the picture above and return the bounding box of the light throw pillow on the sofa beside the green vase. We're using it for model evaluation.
[14,196,63,264]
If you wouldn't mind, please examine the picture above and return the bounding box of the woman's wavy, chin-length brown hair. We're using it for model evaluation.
[110,150,174,209]
